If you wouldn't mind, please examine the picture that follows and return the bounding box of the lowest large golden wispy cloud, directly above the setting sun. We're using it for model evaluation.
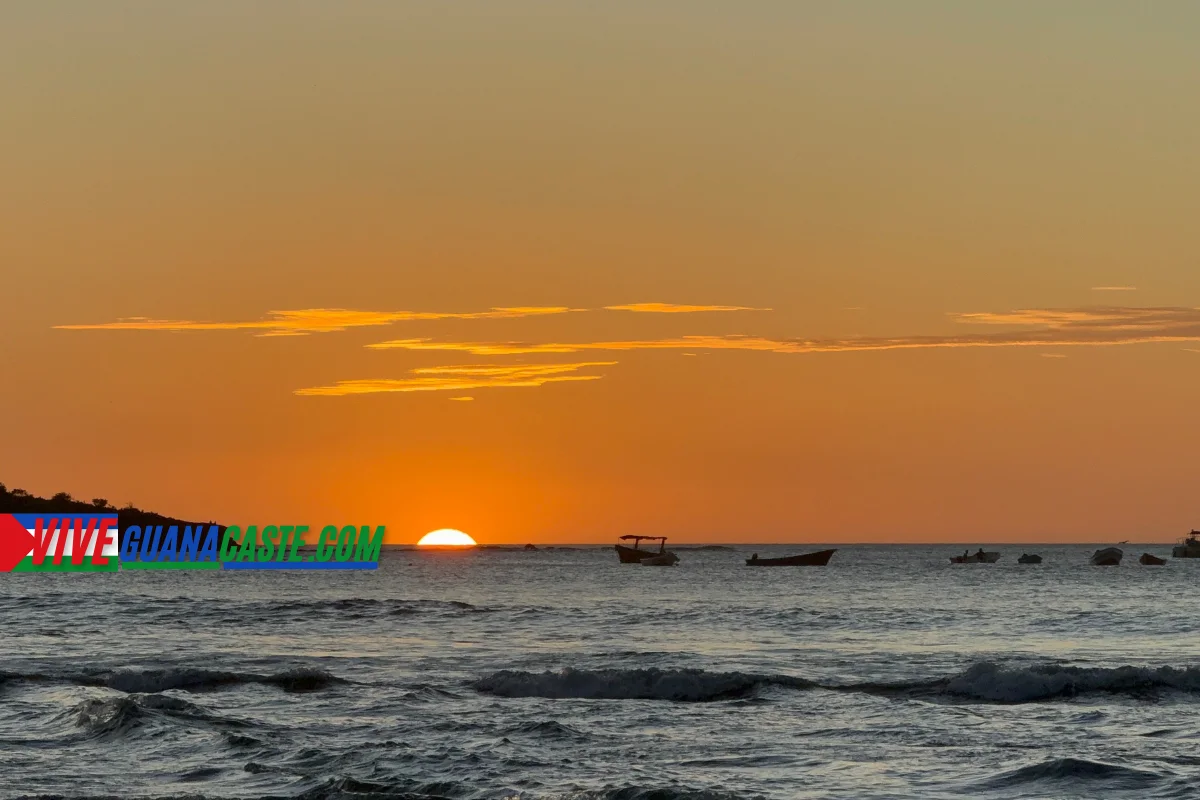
[295,361,617,397]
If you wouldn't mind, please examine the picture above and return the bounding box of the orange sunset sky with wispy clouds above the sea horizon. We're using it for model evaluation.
[0,0,1200,543]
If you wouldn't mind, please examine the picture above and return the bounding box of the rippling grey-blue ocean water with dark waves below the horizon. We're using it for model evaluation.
[0,546,1200,800]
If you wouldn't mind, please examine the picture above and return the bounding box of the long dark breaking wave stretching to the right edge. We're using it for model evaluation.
[472,662,1200,704]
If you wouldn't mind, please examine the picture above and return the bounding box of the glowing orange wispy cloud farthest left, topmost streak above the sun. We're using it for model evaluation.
[54,306,578,336]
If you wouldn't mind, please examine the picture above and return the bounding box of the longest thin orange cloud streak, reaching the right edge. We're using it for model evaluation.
[367,306,1200,355]
